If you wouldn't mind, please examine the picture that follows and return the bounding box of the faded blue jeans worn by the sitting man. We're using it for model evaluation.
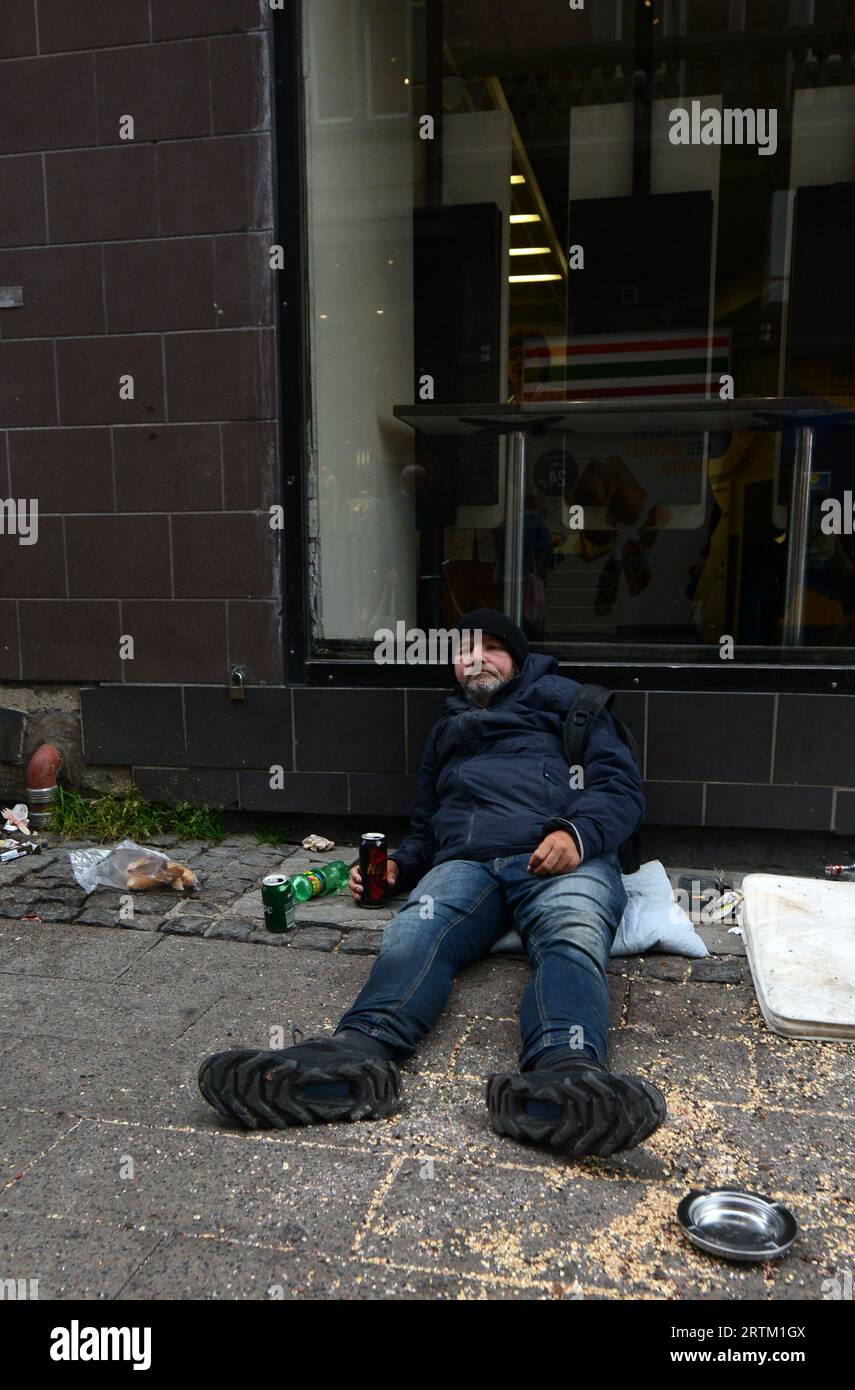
[336,853,627,1070]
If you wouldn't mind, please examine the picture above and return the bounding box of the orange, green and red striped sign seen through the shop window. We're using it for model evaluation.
[523,328,730,400]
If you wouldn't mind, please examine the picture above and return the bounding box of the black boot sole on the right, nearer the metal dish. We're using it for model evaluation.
[487,1069,667,1156]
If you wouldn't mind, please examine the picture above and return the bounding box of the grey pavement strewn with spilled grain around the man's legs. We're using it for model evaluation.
[0,835,855,1300]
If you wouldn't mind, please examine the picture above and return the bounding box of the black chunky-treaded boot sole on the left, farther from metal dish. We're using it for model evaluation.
[199,1048,400,1129]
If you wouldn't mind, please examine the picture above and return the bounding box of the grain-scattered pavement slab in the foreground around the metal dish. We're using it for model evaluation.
[357,1159,851,1300]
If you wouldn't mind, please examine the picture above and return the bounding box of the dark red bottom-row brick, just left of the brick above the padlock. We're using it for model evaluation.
[122,600,228,685]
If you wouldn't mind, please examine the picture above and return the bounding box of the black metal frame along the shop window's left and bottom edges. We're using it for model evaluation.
[271,0,855,695]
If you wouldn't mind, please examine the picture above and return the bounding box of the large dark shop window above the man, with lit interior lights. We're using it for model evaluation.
[303,0,855,663]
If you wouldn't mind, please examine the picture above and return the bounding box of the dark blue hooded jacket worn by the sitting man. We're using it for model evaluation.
[391,653,644,890]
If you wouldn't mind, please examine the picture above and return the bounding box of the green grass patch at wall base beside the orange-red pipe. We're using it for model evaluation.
[49,785,225,844]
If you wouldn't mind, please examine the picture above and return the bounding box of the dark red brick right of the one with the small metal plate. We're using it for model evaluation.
[104,236,217,334]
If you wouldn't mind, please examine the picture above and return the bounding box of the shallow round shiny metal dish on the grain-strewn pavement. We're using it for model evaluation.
[677,1187,798,1261]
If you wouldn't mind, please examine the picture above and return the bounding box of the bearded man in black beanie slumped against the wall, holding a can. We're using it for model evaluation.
[199,609,666,1155]
